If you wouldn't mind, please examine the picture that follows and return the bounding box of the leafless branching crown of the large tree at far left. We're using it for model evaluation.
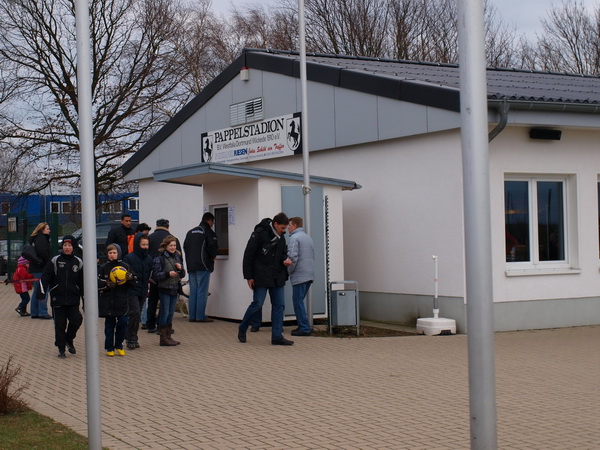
[0,0,189,199]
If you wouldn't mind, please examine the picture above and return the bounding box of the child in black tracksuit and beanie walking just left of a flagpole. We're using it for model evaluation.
[41,236,83,358]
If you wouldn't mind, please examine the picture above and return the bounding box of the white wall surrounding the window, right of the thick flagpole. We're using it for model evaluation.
[490,127,600,301]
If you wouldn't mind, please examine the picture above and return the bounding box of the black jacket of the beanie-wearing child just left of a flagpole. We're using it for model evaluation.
[41,253,83,306]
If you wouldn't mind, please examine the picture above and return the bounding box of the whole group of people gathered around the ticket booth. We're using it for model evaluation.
[13,212,314,358]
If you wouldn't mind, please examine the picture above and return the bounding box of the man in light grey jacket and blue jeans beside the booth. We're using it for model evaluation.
[288,217,315,336]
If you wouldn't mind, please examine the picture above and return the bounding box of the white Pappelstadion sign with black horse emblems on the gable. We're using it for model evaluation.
[200,113,302,164]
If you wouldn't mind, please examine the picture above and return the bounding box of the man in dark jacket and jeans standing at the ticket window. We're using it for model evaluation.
[183,212,219,322]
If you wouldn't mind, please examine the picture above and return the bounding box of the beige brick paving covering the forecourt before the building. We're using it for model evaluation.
[0,284,600,450]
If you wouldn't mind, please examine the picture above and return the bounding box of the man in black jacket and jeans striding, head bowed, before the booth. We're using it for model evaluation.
[238,213,294,345]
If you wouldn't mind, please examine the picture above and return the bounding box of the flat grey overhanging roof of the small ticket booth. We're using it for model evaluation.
[153,163,361,190]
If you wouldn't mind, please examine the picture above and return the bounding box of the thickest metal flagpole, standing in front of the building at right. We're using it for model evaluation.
[458,0,497,450]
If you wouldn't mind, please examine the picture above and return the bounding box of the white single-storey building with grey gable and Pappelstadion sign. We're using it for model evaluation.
[123,50,600,332]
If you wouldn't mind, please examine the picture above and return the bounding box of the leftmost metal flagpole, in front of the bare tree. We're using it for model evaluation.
[75,0,102,450]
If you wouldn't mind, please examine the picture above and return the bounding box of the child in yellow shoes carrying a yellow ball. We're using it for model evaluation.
[98,244,135,356]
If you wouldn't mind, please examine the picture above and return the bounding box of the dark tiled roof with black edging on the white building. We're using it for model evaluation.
[122,49,600,174]
